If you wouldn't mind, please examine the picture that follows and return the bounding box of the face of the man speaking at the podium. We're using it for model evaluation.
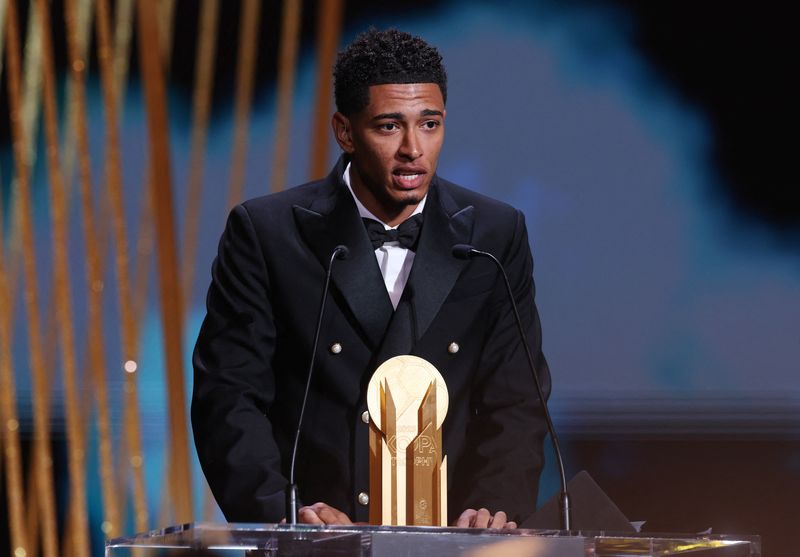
[333,83,445,226]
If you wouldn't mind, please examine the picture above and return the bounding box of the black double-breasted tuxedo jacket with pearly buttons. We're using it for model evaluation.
[192,155,550,522]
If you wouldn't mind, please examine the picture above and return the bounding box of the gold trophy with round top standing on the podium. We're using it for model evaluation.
[367,356,448,526]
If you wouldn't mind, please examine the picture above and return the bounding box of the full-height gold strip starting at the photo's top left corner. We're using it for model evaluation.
[6,0,58,557]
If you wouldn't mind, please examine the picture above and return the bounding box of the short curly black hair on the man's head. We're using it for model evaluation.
[333,27,447,116]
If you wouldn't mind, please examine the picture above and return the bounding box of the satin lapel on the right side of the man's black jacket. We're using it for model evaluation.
[406,179,473,340]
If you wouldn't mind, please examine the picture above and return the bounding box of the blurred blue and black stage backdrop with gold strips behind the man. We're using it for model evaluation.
[0,0,800,557]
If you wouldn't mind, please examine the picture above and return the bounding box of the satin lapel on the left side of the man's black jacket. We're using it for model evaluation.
[293,164,393,348]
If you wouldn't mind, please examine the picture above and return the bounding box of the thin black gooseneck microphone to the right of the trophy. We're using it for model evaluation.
[452,244,572,530]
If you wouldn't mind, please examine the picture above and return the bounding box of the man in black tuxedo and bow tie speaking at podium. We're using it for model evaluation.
[192,29,550,528]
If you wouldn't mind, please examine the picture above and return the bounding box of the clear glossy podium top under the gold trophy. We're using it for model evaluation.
[106,523,761,557]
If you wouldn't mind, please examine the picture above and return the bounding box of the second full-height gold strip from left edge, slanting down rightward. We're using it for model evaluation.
[36,0,90,557]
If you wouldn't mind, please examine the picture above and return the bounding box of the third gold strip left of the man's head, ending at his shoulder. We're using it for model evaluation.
[228,0,261,208]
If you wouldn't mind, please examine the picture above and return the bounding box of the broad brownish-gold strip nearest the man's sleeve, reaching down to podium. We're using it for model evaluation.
[137,0,192,522]
